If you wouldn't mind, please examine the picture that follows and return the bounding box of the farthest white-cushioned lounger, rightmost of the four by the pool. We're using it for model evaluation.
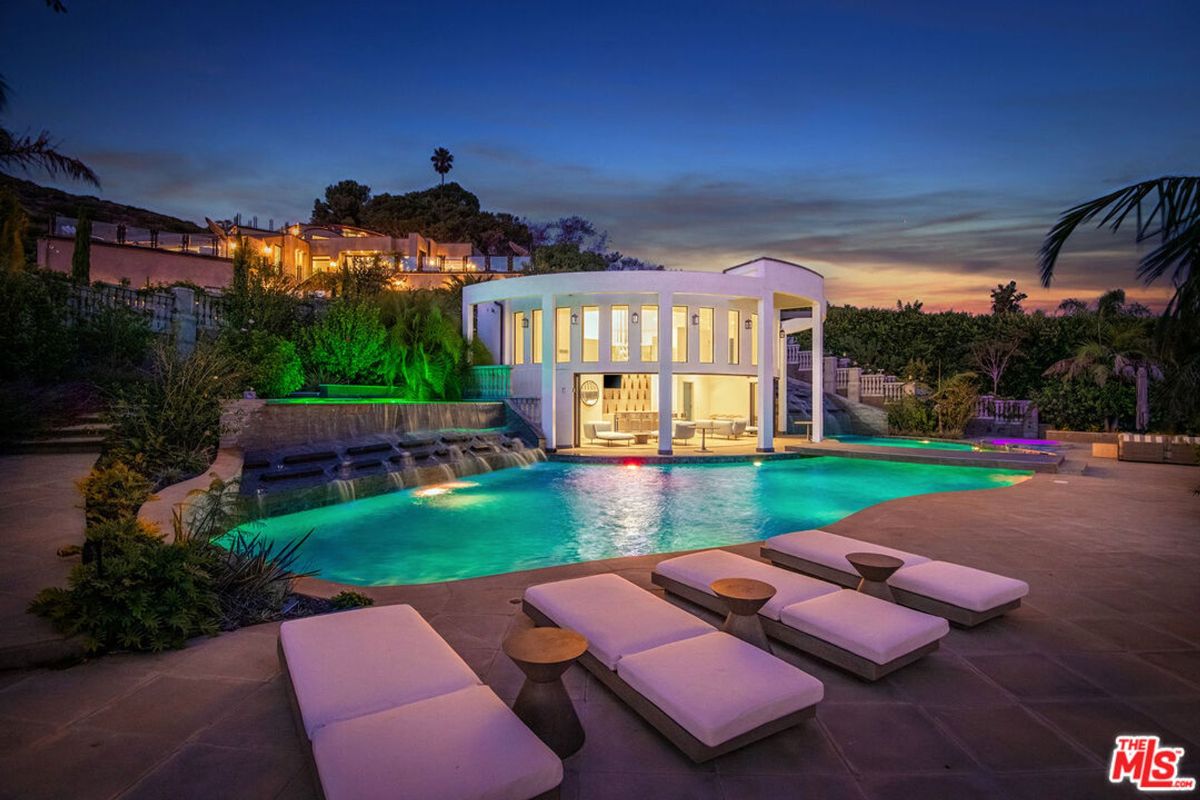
[762,530,1030,627]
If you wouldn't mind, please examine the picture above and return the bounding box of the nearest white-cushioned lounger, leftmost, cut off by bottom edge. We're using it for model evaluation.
[278,606,563,800]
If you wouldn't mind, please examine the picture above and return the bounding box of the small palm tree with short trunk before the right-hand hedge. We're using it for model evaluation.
[1045,314,1163,431]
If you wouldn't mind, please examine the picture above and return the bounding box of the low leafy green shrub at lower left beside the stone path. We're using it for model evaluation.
[30,519,220,652]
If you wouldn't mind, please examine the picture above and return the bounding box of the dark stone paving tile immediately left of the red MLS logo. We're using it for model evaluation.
[932,705,1088,771]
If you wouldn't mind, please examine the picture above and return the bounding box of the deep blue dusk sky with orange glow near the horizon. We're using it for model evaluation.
[0,0,1200,309]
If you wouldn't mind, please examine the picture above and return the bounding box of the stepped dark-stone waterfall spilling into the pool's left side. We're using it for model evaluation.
[240,403,546,517]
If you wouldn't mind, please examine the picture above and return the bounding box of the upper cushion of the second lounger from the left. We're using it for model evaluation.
[524,573,715,669]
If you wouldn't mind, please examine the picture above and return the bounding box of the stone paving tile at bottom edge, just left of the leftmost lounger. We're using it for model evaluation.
[120,742,305,800]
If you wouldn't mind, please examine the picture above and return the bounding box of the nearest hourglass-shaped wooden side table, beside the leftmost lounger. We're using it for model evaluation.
[504,627,588,758]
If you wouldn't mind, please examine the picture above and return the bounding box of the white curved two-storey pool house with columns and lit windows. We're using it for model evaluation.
[462,258,826,455]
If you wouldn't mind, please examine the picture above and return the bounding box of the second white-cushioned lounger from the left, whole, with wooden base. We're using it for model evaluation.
[524,573,824,762]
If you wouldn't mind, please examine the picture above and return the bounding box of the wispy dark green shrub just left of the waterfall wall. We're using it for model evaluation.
[107,343,242,487]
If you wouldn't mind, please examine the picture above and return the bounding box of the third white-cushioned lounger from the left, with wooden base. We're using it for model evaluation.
[650,551,950,680]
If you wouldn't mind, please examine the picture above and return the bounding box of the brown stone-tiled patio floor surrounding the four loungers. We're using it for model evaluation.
[0,453,1200,800]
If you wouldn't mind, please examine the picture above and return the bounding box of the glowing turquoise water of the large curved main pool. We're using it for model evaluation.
[238,457,1030,585]
